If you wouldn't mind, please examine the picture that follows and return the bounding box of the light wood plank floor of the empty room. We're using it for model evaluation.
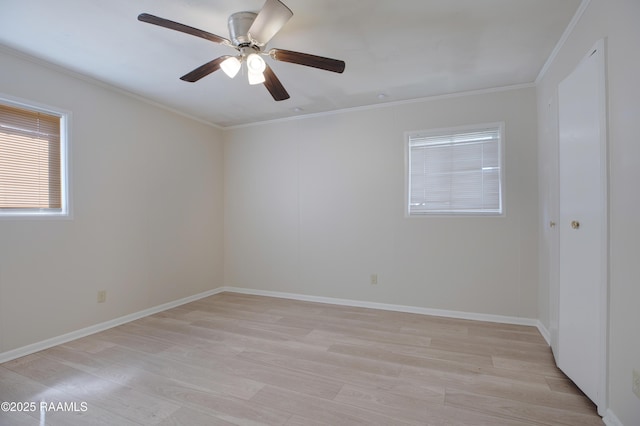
[0,293,603,426]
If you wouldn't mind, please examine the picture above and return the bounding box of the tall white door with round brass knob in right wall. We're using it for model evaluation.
[557,42,608,414]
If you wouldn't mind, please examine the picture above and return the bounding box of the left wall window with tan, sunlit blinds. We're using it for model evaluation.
[0,99,69,216]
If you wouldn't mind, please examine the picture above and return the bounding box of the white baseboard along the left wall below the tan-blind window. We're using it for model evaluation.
[0,287,225,364]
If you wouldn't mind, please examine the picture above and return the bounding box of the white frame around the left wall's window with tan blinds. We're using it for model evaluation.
[0,93,72,220]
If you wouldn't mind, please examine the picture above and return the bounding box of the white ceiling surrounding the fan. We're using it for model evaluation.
[0,0,581,127]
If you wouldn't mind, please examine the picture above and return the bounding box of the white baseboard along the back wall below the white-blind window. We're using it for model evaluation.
[222,286,548,330]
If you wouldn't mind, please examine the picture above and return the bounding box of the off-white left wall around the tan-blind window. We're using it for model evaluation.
[0,50,223,353]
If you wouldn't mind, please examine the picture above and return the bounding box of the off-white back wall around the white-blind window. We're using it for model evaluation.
[225,88,538,318]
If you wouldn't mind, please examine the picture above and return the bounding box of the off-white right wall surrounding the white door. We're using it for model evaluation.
[537,0,640,426]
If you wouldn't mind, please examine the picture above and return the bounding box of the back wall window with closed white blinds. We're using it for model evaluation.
[407,124,503,216]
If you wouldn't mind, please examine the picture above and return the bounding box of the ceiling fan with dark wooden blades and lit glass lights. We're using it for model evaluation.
[138,0,345,101]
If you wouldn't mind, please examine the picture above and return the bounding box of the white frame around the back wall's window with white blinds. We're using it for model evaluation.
[404,122,506,218]
